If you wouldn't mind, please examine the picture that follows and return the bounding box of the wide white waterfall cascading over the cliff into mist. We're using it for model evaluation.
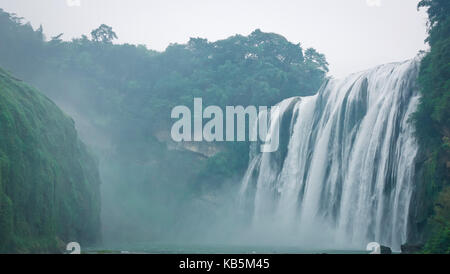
[241,58,419,250]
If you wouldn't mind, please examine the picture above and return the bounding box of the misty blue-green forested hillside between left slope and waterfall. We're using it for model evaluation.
[0,7,328,245]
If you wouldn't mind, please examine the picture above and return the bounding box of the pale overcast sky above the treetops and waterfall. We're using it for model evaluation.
[0,0,426,77]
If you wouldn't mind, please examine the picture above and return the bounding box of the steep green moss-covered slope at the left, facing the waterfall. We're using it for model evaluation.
[0,69,100,253]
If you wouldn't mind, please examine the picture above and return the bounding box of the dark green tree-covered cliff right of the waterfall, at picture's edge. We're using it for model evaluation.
[414,0,450,253]
